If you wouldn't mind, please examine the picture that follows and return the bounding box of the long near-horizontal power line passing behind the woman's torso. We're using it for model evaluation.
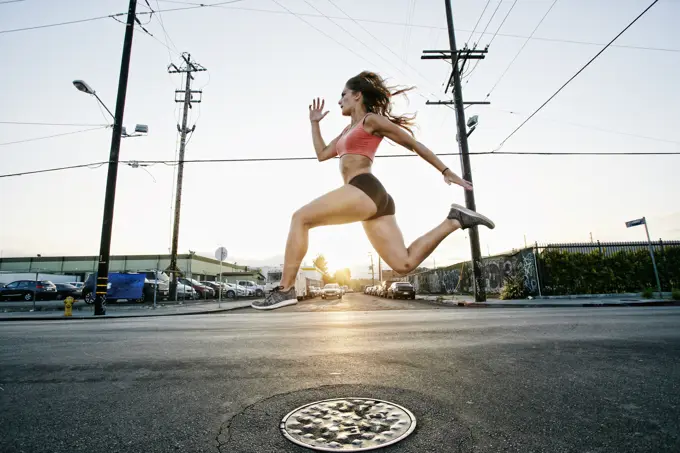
[0,151,680,178]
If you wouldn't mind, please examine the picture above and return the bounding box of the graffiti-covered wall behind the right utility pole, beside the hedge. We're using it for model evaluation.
[407,249,538,294]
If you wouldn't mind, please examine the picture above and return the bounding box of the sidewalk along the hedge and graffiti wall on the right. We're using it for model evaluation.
[416,294,680,308]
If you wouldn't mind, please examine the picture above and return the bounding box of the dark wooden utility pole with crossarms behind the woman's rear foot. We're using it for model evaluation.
[421,0,489,302]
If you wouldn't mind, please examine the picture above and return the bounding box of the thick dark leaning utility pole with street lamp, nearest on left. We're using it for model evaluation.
[94,0,137,316]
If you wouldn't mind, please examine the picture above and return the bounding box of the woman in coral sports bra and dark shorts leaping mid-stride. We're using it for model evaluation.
[252,71,495,310]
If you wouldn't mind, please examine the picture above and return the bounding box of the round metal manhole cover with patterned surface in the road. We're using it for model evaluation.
[281,398,416,451]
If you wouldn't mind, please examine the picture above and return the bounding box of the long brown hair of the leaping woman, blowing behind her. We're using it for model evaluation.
[347,71,416,135]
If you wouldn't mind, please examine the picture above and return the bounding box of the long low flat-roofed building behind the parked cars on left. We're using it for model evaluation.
[0,253,265,284]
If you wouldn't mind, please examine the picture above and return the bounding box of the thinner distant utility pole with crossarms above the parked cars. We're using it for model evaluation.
[168,53,206,300]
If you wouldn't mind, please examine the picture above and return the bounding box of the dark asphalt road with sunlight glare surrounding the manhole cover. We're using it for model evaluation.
[0,295,680,453]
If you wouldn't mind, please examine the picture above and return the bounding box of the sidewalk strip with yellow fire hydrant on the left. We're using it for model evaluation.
[0,299,256,321]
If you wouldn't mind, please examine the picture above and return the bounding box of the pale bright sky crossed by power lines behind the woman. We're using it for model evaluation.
[0,0,680,276]
